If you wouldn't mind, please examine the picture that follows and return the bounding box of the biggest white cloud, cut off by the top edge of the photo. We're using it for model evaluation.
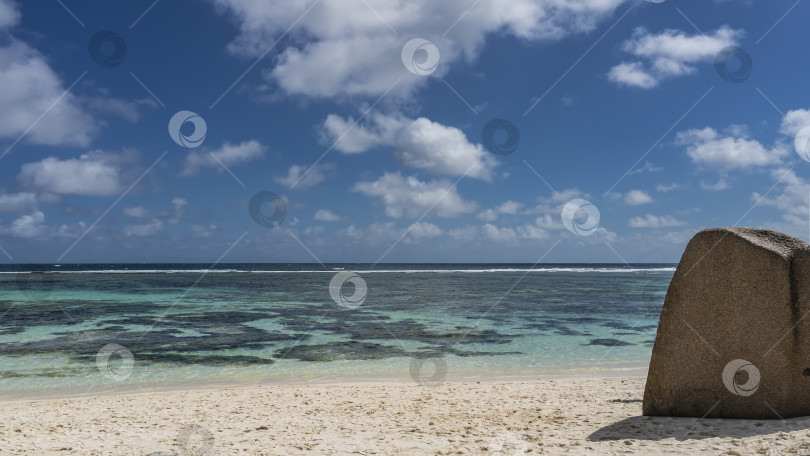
[212,0,623,97]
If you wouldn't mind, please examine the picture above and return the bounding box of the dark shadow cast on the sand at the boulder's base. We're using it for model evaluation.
[588,416,810,442]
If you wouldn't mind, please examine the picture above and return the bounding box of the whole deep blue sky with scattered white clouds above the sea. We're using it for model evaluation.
[0,0,810,263]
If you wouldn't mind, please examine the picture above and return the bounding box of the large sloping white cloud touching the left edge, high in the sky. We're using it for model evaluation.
[0,39,97,146]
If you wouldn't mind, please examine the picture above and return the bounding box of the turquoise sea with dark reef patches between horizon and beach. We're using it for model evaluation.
[0,263,675,397]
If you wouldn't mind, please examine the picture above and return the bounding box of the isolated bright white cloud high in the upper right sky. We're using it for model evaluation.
[608,26,743,89]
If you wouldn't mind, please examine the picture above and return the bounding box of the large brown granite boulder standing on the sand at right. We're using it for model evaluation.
[643,227,810,419]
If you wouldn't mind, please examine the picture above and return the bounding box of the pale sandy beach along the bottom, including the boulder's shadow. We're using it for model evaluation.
[0,377,810,456]
